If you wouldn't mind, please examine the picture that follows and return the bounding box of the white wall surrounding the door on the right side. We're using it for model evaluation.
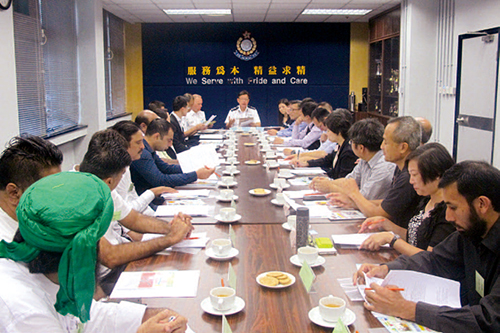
[401,0,500,167]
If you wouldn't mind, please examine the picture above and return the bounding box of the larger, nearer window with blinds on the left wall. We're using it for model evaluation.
[14,0,80,136]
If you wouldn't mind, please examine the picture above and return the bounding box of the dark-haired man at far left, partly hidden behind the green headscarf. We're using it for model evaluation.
[0,136,63,242]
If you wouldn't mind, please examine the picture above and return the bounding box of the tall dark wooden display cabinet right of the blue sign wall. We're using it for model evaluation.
[368,6,401,117]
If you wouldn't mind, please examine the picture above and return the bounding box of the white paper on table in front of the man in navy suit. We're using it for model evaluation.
[177,145,219,173]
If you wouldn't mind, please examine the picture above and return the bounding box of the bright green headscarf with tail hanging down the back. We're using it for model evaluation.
[0,172,113,322]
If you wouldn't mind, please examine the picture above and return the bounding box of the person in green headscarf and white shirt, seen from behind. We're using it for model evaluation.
[0,172,186,333]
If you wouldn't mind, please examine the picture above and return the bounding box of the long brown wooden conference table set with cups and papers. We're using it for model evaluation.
[120,131,395,333]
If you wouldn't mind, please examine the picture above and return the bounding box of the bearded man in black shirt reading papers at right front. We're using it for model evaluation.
[353,161,500,333]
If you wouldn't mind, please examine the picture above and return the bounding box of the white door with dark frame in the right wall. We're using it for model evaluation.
[453,29,499,163]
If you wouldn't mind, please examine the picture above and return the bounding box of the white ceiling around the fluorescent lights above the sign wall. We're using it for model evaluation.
[103,0,401,23]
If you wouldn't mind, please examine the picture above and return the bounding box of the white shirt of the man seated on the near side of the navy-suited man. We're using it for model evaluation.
[116,167,155,216]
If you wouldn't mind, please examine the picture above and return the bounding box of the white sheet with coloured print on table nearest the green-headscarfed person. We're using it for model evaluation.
[111,270,200,298]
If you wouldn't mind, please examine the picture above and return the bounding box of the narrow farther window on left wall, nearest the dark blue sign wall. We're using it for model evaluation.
[103,11,125,120]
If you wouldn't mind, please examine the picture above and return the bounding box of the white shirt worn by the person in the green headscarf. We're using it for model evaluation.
[0,259,146,333]
